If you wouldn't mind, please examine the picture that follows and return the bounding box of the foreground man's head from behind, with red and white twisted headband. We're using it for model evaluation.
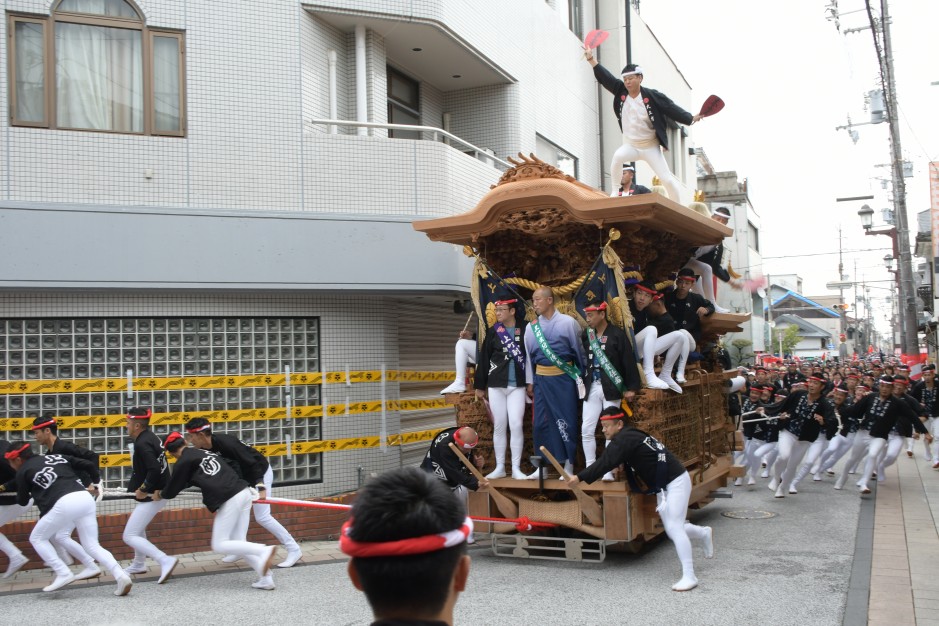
[339,467,473,626]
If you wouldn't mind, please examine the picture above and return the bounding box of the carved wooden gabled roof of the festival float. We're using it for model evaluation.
[413,154,733,285]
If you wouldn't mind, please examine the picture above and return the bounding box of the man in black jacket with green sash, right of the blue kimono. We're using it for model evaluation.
[580,301,642,482]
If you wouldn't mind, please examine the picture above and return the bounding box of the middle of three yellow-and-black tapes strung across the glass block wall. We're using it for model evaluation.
[0,398,448,431]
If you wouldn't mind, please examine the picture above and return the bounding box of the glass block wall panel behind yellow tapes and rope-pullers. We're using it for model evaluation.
[0,317,323,488]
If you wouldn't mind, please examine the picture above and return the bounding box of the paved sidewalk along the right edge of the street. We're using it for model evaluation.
[868,454,939,626]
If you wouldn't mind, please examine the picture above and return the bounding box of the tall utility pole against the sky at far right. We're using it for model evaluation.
[866,0,919,355]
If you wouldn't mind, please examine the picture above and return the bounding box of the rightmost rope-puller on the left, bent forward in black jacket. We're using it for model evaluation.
[186,417,303,567]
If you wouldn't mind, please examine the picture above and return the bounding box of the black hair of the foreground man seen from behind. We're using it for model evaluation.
[349,467,466,617]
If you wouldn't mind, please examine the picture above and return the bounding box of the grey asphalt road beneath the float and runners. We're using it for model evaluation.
[11,477,859,626]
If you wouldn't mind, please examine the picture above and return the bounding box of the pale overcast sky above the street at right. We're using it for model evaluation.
[633,0,939,326]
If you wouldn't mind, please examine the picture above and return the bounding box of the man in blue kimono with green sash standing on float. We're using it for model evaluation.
[525,286,584,480]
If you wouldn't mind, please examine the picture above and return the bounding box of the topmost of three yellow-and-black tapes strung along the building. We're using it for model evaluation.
[0,370,455,395]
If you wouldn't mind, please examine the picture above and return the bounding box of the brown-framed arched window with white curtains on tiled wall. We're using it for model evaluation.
[9,0,185,136]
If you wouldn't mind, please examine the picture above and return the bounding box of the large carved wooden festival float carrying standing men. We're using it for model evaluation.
[414,154,747,560]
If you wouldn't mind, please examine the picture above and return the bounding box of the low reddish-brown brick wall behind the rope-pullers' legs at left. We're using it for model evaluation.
[0,493,355,569]
